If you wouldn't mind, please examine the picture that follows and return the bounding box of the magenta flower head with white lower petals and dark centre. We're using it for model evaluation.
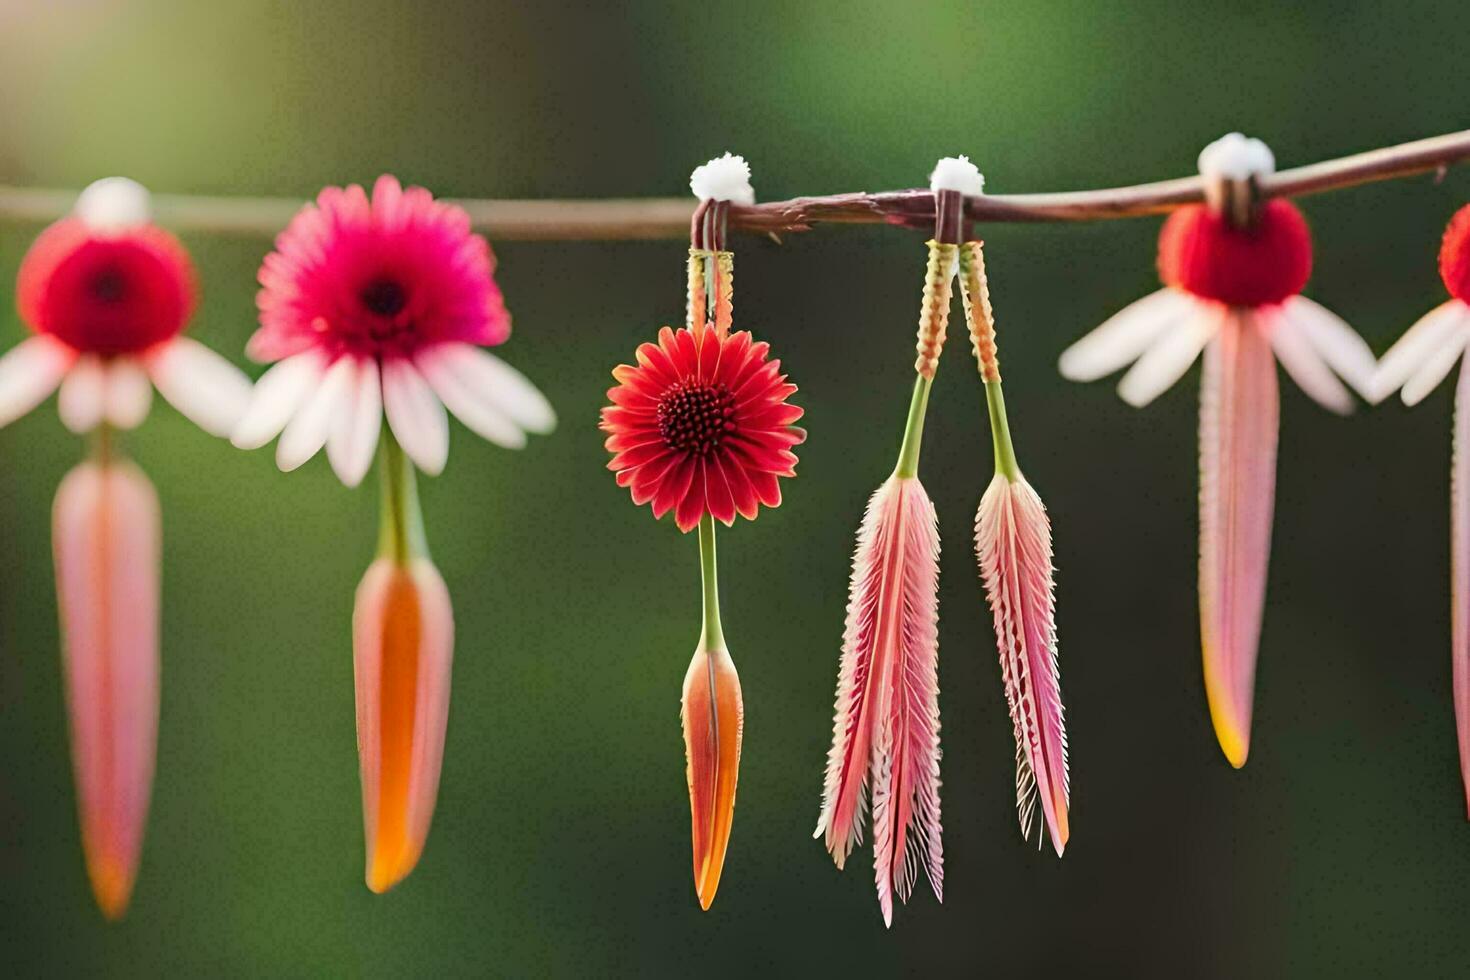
[234,175,556,486]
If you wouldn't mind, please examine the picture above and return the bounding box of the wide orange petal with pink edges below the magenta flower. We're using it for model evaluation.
[353,558,454,892]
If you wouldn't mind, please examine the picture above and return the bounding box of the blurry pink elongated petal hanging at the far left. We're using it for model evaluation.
[51,461,162,918]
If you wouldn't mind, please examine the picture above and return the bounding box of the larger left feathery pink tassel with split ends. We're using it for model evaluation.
[813,476,944,924]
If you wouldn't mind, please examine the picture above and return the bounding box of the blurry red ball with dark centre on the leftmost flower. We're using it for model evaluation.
[16,217,196,354]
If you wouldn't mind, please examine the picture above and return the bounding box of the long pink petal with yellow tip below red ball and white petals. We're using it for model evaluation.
[1200,310,1280,768]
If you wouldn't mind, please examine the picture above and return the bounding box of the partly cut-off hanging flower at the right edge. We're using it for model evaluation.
[1372,204,1470,813]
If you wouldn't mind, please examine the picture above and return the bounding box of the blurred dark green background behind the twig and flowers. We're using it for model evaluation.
[0,0,1470,977]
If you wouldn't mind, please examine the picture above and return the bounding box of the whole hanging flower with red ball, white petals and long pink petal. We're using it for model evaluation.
[1060,134,1374,768]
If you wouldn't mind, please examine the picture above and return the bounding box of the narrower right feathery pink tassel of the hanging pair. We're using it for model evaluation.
[975,473,1070,858]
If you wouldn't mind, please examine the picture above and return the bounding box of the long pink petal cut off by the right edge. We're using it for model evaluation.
[1449,359,1470,817]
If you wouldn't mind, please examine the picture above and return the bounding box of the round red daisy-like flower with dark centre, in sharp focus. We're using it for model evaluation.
[601,326,807,532]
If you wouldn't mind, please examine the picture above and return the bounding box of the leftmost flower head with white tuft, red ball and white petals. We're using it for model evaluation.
[0,178,250,435]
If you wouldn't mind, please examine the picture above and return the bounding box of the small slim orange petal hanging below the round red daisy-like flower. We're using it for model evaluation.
[679,648,745,911]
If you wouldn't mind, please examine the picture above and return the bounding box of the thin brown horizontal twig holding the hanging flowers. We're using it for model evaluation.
[0,129,1470,241]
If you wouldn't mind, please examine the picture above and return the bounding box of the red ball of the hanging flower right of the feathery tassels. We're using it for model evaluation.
[1158,200,1311,306]
